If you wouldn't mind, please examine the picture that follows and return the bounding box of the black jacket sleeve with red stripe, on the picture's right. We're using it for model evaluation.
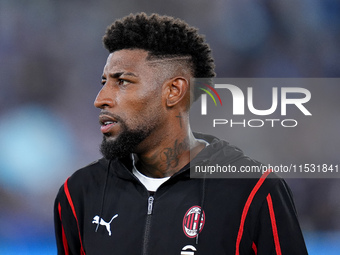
[253,180,308,255]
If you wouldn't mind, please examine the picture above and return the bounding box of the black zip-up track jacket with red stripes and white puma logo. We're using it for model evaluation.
[54,134,307,255]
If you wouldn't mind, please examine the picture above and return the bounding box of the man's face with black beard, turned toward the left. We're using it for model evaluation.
[94,50,162,159]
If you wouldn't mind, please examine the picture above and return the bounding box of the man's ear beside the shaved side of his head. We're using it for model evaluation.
[166,77,189,107]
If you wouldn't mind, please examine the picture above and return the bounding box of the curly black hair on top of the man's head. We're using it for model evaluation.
[103,13,215,100]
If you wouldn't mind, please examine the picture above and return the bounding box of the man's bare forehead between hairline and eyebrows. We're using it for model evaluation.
[104,49,148,73]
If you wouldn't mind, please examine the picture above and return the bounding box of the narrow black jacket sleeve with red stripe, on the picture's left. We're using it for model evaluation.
[54,182,85,255]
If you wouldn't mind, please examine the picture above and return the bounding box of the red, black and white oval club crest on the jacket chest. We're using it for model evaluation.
[183,205,205,238]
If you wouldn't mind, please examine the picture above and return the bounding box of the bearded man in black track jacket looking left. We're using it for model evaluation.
[55,13,307,255]
